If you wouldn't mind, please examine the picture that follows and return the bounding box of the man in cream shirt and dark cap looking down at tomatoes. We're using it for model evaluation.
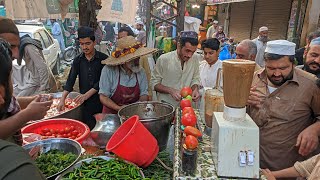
[151,31,203,107]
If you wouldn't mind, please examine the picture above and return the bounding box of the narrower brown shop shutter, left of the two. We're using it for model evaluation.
[229,1,254,42]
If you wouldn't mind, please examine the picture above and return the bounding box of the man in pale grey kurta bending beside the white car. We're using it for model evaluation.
[13,35,57,97]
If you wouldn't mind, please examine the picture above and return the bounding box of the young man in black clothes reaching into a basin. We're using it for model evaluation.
[58,26,108,129]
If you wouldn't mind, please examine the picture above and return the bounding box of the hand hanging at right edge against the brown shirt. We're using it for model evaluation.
[296,125,319,156]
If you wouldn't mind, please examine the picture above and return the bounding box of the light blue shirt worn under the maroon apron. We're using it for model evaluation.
[99,65,148,98]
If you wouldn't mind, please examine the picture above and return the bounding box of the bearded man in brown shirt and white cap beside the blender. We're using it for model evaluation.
[248,40,320,171]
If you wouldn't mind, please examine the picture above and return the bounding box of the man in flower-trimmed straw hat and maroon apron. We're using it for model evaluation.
[99,36,156,114]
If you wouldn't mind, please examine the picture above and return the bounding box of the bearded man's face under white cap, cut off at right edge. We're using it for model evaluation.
[300,37,320,78]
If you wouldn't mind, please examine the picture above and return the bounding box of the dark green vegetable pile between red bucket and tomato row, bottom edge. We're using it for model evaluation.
[143,151,173,180]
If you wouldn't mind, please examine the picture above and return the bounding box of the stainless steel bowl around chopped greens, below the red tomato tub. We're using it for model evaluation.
[23,138,81,179]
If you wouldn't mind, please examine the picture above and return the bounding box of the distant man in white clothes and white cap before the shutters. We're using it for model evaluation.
[252,26,269,67]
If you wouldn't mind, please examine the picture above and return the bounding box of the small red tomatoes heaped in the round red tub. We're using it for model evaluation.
[40,126,83,139]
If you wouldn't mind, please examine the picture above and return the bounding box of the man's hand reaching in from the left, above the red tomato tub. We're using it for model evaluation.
[23,96,52,120]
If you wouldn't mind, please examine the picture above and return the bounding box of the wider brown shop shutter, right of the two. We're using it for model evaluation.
[251,0,292,40]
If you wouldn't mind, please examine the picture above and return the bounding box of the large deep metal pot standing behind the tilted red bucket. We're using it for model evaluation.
[118,101,175,151]
